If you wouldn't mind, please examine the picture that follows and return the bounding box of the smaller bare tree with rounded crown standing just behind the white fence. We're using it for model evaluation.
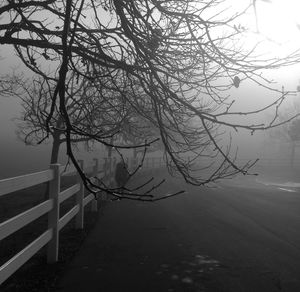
[0,74,126,163]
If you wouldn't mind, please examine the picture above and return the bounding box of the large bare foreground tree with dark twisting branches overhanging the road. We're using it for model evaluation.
[0,0,299,200]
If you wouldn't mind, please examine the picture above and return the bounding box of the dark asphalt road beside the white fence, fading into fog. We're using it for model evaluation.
[59,173,300,292]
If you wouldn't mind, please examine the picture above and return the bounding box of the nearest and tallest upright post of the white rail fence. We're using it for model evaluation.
[47,164,60,263]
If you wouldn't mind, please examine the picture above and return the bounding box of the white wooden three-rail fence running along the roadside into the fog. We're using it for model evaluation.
[0,157,161,285]
